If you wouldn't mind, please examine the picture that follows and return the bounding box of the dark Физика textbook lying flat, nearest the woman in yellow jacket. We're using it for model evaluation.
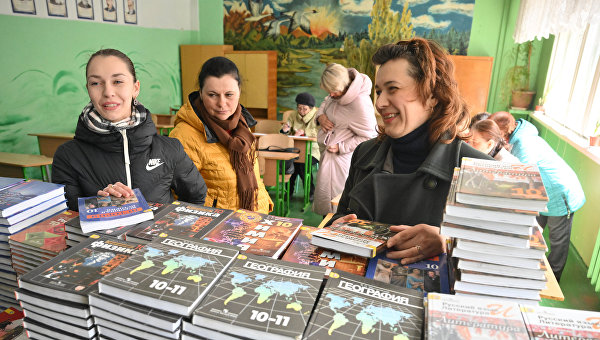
[127,201,233,242]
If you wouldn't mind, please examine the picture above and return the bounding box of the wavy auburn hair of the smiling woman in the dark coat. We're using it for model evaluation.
[372,38,470,144]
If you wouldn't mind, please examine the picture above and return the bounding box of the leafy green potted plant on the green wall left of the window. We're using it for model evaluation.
[503,41,535,110]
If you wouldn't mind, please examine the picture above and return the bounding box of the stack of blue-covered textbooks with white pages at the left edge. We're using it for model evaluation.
[0,177,67,308]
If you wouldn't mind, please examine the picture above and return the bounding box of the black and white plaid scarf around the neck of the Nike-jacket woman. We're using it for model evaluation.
[81,99,148,134]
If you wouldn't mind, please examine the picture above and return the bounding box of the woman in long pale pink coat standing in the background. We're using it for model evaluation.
[313,64,377,215]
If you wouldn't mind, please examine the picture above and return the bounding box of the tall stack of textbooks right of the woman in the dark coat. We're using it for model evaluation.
[441,158,548,304]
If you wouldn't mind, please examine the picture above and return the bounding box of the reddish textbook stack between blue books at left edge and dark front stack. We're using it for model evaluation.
[8,210,78,276]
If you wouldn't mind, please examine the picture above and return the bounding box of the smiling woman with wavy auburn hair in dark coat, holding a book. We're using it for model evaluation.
[332,38,491,264]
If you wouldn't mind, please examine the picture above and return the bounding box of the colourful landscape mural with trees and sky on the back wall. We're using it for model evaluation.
[223,0,475,112]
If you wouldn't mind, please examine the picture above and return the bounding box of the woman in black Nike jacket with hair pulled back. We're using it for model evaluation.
[52,49,206,210]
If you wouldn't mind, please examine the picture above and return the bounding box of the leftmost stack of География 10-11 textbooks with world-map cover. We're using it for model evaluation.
[90,236,239,339]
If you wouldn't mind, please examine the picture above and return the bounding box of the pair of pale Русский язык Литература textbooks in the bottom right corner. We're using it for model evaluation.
[425,293,600,340]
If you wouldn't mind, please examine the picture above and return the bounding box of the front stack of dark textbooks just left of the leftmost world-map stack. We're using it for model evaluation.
[15,236,141,339]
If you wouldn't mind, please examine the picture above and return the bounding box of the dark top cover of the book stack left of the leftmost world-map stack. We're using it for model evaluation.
[29,237,142,292]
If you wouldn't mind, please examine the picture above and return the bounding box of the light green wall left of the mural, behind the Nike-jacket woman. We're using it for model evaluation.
[0,0,223,154]
